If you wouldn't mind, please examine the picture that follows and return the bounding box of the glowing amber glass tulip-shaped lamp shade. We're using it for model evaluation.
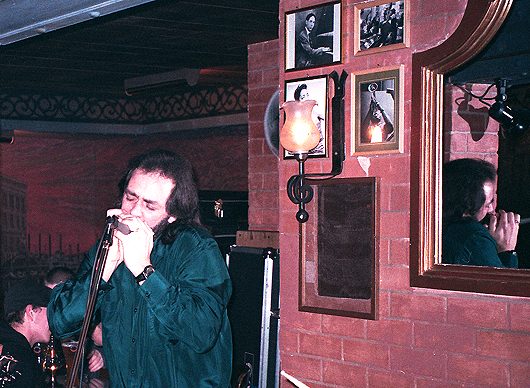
[280,100,320,154]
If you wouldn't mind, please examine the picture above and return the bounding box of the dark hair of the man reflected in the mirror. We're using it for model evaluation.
[442,158,497,229]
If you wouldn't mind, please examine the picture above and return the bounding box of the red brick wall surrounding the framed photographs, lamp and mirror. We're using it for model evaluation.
[245,0,530,388]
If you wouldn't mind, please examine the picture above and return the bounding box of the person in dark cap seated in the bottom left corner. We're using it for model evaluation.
[0,281,51,388]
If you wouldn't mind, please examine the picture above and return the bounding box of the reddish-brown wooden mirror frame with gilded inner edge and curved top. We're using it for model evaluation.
[410,0,530,296]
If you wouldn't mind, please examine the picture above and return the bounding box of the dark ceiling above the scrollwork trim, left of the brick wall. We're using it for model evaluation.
[0,0,279,96]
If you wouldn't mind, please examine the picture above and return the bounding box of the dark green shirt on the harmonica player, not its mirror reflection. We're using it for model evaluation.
[48,226,232,388]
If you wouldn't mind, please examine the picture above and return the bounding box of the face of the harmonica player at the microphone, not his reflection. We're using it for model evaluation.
[121,170,175,230]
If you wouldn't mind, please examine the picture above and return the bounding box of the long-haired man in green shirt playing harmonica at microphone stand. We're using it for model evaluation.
[48,150,232,388]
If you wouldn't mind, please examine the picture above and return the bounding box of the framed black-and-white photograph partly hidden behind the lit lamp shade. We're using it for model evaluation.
[284,76,328,158]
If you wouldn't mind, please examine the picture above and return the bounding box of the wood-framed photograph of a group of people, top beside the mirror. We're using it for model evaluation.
[353,0,410,55]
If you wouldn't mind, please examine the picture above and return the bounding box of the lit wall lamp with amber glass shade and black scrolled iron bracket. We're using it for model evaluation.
[280,70,348,223]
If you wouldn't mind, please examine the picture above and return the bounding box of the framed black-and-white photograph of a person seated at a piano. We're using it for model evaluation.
[285,2,342,70]
